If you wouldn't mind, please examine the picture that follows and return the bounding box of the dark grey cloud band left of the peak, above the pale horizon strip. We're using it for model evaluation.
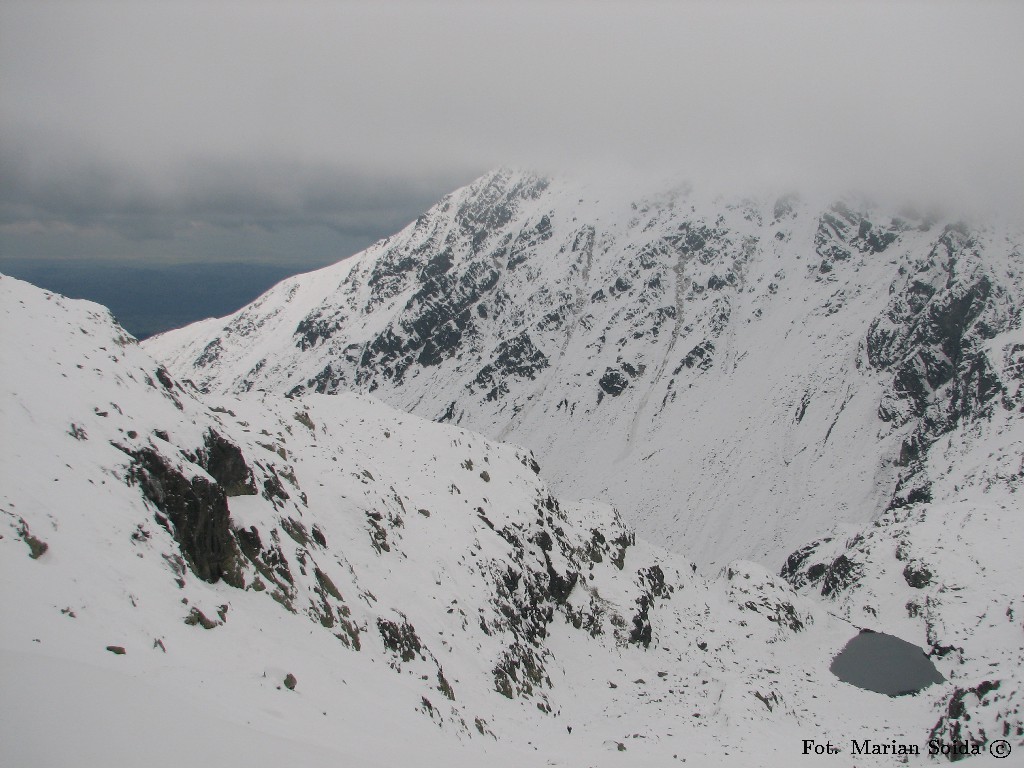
[0,137,472,238]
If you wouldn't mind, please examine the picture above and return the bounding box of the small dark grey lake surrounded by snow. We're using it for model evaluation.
[828,630,945,696]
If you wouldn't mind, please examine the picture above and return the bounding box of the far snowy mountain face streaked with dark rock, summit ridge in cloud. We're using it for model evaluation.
[145,170,1024,567]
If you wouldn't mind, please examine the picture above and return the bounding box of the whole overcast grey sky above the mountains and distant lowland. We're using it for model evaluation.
[0,0,1024,266]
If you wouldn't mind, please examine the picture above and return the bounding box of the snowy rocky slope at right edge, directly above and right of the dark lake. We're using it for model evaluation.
[783,403,1024,757]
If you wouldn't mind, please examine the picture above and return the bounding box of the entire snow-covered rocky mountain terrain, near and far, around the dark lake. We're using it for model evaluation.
[0,160,1024,766]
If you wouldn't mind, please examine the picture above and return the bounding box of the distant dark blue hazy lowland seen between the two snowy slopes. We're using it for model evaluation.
[0,259,311,339]
